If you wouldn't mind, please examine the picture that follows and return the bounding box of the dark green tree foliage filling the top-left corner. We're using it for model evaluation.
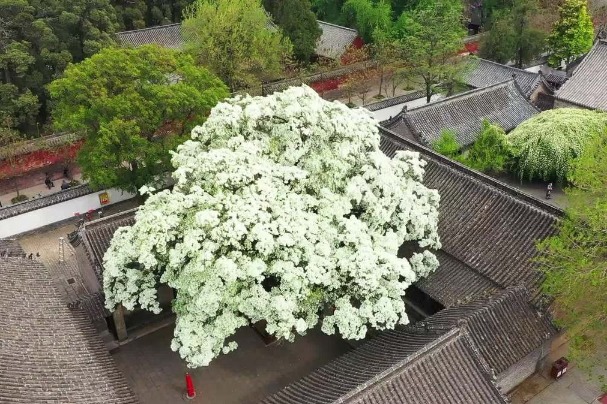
[0,0,116,132]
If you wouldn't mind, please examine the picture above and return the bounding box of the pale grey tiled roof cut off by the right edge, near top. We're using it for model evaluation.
[556,39,607,111]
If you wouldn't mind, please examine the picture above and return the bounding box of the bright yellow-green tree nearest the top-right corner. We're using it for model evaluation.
[548,0,594,67]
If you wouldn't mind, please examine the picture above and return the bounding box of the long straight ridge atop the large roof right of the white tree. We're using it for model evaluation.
[379,127,564,219]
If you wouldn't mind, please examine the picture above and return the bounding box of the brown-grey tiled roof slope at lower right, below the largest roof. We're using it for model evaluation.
[423,286,557,374]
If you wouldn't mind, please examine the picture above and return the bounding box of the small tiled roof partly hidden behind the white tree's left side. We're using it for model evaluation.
[79,208,137,282]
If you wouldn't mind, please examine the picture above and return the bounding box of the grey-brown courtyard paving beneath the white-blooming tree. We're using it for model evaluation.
[112,326,351,404]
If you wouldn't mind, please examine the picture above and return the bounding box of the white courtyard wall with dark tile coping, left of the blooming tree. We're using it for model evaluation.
[0,186,135,238]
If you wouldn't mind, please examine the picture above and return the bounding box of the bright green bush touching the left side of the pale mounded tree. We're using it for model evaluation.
[459,120,511,173]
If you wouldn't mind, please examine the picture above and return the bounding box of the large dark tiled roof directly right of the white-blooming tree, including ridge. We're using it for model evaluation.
[380,129,563,306]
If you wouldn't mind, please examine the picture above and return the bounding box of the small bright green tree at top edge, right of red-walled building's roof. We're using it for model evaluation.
[343,0,392,42]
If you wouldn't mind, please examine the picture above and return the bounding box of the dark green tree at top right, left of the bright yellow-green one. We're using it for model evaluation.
[479,0,546,68]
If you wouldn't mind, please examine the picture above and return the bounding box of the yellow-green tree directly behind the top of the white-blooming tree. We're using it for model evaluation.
[182,0,292,91]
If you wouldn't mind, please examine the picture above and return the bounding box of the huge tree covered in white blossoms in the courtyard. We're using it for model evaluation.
[104,87,440,367]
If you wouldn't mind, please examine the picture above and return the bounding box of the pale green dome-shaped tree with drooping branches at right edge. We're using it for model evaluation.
[508,108,607,181]
